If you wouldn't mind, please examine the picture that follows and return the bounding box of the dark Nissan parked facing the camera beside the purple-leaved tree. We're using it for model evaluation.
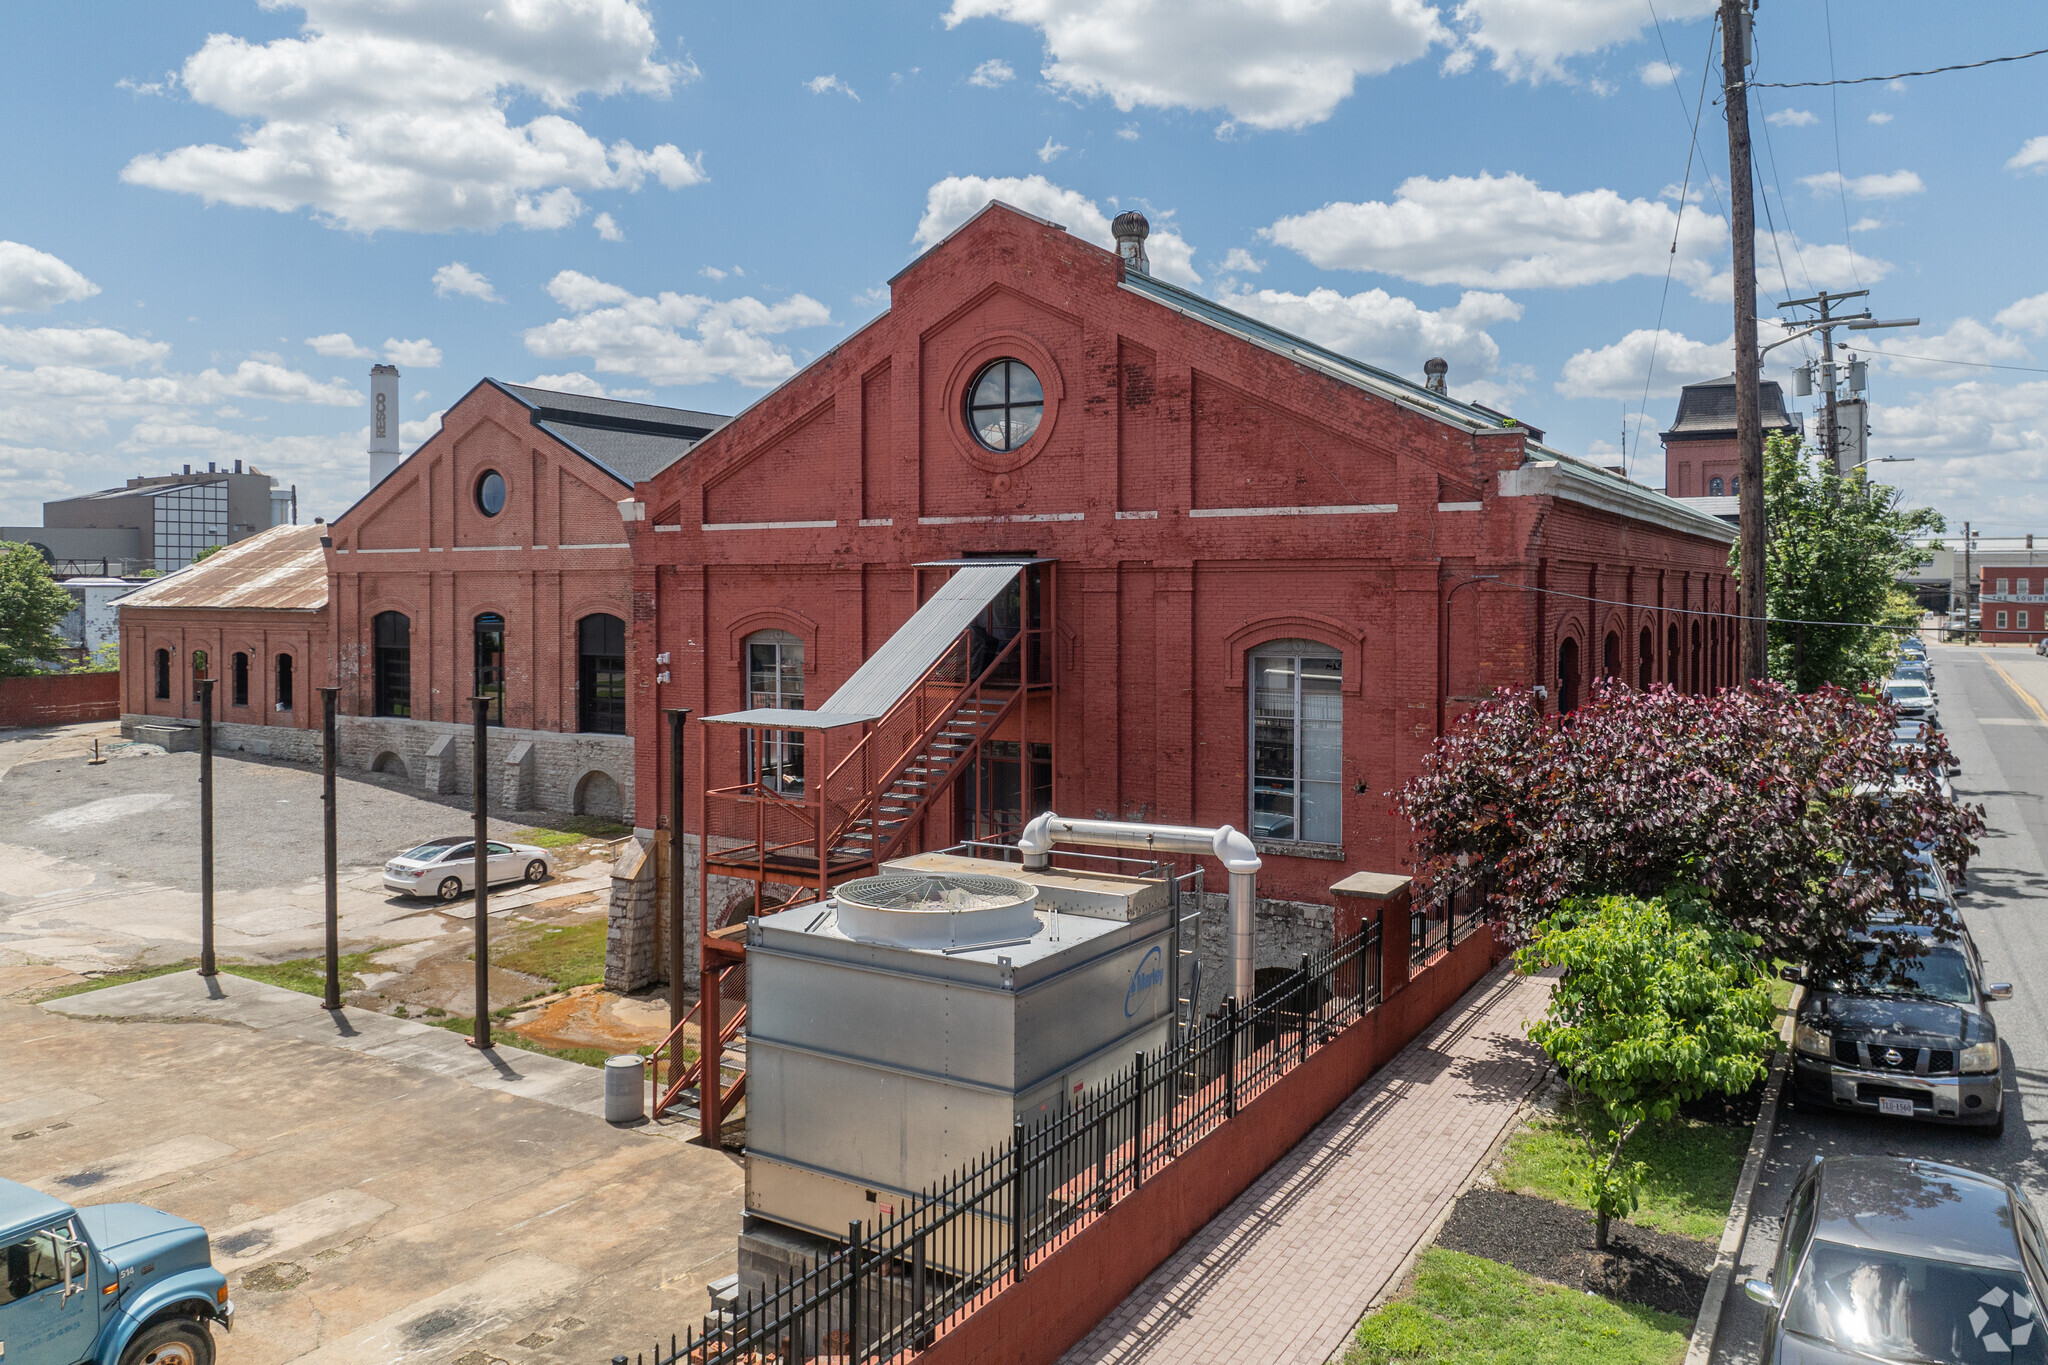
[1786,925,2013,1138]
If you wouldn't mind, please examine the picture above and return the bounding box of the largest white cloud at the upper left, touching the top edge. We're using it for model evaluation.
[121,0,705,231]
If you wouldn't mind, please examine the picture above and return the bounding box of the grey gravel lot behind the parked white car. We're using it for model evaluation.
[0,753,549,890]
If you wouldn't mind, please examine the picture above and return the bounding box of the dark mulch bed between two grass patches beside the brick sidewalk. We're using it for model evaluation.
[1436,1187,1714,1318]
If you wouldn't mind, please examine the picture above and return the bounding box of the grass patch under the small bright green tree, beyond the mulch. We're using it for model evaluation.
[1499,1111,1749,1242]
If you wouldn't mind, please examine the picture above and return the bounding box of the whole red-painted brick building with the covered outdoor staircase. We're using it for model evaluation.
[612,205,1735,1002]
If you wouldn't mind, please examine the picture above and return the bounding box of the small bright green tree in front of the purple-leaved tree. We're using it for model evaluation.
[1518,896,1778,1248]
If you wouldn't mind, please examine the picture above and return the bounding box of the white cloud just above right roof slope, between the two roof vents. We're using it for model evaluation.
[1219,289,1522,397]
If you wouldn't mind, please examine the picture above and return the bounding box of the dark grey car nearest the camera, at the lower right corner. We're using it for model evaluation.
[1743,1156,2048,1365]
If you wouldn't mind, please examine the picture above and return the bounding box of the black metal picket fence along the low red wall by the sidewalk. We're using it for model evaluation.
[612,908,1392,1365]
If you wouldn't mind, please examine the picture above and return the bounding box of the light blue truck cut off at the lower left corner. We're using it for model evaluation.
[0,1179,236,1365]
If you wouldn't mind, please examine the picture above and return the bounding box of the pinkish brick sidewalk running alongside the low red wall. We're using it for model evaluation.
[1061,970,1550,1365]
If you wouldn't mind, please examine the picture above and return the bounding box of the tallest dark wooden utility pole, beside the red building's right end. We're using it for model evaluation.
[1720,0,1769,681]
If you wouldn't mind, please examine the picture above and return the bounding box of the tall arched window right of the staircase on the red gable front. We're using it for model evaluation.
[1251,641,1343,843]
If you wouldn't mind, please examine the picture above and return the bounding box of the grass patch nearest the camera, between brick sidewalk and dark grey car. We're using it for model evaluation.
[1343,1248,1692,1365]
